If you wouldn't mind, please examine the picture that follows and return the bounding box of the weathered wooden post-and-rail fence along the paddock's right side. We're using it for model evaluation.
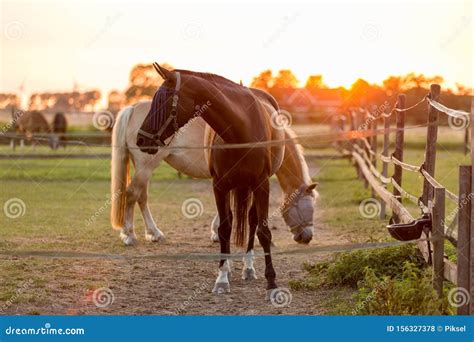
[335,85,474,314]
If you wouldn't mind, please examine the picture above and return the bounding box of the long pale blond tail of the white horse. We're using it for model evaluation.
[110,106,133,229]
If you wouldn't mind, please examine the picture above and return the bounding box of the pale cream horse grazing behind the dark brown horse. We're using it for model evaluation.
[111,101,318,246]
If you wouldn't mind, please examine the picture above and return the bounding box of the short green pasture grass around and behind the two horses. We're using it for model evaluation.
[0,125,470,307]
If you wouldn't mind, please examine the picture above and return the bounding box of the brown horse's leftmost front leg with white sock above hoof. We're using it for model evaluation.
[212,183,232,294]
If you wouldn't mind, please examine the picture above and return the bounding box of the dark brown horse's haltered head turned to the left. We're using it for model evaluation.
[137,63,195,154]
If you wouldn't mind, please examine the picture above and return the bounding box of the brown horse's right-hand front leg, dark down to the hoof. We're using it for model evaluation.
[254,179,277,298]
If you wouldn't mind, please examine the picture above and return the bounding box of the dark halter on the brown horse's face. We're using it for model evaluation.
[138,72,181,147]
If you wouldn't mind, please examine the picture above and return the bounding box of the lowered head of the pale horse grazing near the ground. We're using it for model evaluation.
[282,183,317,243]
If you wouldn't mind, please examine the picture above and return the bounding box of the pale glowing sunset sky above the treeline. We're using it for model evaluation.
[0,0,473,104]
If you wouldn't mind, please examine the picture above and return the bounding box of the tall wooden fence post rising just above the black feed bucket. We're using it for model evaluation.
[422,84,441,208]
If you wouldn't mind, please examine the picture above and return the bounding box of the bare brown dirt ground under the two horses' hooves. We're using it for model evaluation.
[2,162,347,315]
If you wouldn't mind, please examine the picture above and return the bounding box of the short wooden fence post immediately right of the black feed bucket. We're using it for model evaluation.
[431,187,446,297]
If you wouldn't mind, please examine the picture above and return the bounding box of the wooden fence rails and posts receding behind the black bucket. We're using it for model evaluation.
[336,84,474,315]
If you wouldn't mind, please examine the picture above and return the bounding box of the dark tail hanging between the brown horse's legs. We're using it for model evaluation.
[232,187,252,247]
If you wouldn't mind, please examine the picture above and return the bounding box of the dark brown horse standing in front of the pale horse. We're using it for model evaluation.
[137,64,284,295]
